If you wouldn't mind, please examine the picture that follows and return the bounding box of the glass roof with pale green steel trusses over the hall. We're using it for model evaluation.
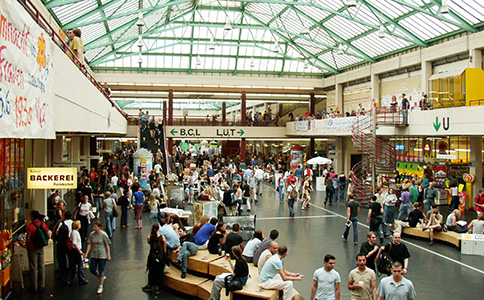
[42,0,484,110]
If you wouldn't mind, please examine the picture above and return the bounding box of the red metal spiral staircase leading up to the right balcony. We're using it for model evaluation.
[350,114,397,203]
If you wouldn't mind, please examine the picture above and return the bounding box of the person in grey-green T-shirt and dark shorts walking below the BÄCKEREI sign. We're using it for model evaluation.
[84,221,111,295]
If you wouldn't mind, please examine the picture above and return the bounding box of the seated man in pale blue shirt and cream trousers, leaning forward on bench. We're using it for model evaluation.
[259,245,302,300]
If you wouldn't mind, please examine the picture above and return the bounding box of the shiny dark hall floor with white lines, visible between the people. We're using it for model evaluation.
[10,185,484,300]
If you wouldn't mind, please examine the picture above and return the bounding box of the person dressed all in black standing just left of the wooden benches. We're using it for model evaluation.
[142,223,166,295]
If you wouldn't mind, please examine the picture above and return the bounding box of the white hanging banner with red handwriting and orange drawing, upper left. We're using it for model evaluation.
[0,0,55,139]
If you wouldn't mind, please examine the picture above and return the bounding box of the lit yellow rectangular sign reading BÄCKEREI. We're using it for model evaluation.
[27,168,77,189]
